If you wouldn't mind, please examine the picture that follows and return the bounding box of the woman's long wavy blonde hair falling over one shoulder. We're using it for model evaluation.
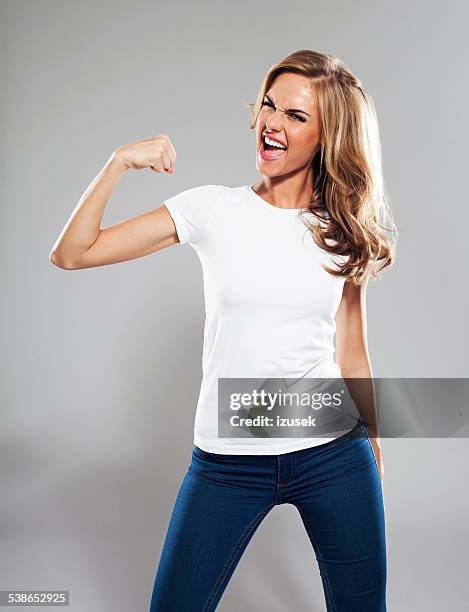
[248,50,397,285]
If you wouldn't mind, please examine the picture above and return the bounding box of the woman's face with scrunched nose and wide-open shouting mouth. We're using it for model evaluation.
[252,72,321,177]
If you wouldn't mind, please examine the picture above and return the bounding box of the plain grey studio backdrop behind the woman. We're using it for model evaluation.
[0,0,469,612]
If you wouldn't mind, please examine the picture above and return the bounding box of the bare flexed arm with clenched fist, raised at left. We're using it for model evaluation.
[49,134,178,270]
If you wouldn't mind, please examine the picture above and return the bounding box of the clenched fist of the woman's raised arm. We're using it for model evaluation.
[114,134,176,174]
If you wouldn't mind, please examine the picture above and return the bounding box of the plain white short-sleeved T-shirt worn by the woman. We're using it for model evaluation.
[165,185,350,455]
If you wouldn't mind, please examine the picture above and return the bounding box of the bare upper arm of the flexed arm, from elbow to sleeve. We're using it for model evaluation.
[68,203,179,269]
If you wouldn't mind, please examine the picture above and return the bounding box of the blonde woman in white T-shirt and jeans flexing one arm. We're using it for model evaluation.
[51,50,395,612]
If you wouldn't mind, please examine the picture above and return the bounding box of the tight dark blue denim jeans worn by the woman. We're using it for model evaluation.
[150,420,386,612]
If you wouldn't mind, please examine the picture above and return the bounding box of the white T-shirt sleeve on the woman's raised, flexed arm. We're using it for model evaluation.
[163,185,219,244]
